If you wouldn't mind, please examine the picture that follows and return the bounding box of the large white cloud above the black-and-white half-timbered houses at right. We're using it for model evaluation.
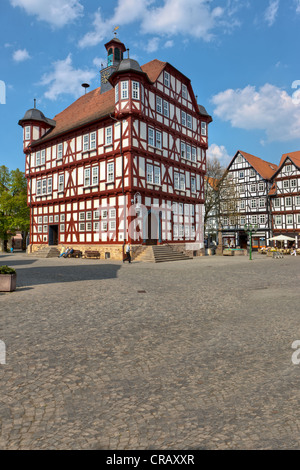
[212,83,300,142]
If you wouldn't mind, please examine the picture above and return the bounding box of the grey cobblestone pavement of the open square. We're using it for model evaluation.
[0,253,300,450]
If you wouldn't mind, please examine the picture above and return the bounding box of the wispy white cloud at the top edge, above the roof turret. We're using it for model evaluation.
[79,0,239,48]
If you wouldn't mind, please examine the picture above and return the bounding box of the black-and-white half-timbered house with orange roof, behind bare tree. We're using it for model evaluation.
[222,150,277,248]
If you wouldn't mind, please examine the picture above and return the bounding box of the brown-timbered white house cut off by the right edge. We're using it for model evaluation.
[269,151,300,248]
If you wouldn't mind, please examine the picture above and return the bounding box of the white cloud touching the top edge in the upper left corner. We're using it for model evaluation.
[10,0,83,27]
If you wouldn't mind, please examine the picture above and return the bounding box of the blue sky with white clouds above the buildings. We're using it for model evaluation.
[0,0,300,170]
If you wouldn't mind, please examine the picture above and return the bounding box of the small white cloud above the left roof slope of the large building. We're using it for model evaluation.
[39,54,97,100]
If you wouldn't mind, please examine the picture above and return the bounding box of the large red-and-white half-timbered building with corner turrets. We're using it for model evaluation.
[19,37,212,258]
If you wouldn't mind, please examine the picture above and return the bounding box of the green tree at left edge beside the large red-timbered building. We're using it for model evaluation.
[0,165,29,252]
